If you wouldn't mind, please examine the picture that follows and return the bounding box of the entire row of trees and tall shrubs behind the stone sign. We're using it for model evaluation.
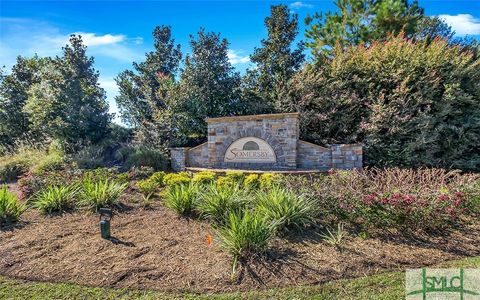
[0,0,480,171]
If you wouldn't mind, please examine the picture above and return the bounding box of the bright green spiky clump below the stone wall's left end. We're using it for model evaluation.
[164,183,200,216]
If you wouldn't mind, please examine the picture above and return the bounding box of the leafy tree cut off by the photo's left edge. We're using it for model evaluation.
[0,56,48,148]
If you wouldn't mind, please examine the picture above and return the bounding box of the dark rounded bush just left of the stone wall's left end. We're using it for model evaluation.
[125,148,169,170]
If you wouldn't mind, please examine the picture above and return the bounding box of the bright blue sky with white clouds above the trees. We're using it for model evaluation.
[0,0,480,121]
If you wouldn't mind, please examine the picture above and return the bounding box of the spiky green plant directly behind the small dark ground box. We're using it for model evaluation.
[79,178,127,211]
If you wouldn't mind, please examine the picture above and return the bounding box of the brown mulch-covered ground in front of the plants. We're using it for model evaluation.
[0,192,480,292]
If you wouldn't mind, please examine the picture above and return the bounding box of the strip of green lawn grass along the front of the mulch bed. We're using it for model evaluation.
[0,256,480,299]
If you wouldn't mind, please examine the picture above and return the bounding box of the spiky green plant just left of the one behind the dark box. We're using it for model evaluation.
[33,185,79,214]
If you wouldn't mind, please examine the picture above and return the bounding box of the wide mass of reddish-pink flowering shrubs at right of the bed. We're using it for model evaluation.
[313,168,480,231]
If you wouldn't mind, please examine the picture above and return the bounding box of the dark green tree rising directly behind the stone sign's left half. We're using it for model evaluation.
[169,29,242,137]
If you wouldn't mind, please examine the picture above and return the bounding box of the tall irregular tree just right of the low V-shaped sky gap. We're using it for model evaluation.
[115,25,182,146]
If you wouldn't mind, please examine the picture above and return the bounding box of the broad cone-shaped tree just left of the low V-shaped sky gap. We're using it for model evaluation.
[23,35,111,146]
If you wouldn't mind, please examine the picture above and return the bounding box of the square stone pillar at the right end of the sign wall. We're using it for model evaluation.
[330,144,363,170]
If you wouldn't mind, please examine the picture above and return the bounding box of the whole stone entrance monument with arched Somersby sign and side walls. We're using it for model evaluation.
[170,113,362,171]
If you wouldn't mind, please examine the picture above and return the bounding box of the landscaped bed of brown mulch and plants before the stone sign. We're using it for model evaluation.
[0,170,480,292]
